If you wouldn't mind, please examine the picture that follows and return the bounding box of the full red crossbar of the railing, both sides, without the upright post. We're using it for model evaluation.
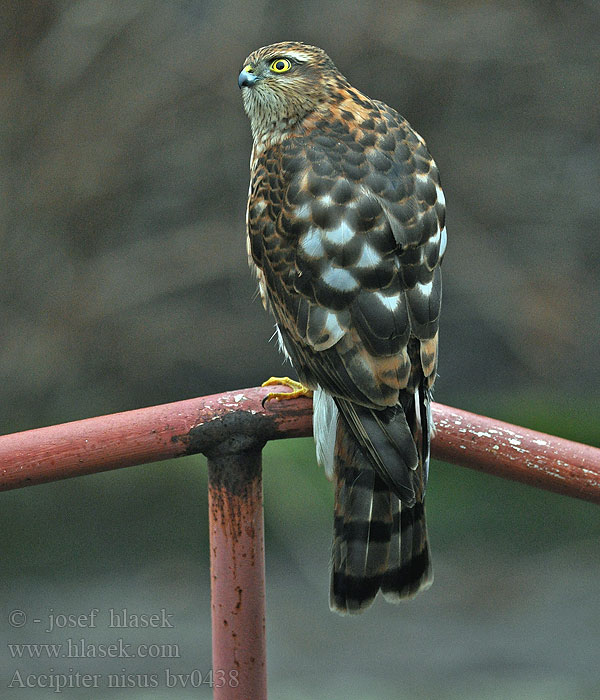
[0,387,600,503]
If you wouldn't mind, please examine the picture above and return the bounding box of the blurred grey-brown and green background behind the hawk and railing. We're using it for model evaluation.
[0,0,600,700]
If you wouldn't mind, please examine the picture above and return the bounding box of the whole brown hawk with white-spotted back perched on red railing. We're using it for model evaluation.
[238,42,446,614]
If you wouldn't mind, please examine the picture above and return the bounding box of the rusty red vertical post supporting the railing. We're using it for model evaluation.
[208,446,267,700]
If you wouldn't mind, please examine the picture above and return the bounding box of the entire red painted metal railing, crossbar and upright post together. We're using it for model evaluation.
[0,387,600,700]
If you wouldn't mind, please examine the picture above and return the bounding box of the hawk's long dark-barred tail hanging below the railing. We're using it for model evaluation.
[330,402,433,614]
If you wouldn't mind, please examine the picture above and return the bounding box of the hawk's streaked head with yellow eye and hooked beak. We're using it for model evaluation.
[238,41,347,142]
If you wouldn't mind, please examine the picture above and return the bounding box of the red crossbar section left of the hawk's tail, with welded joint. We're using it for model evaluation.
[0,387,312,491]
